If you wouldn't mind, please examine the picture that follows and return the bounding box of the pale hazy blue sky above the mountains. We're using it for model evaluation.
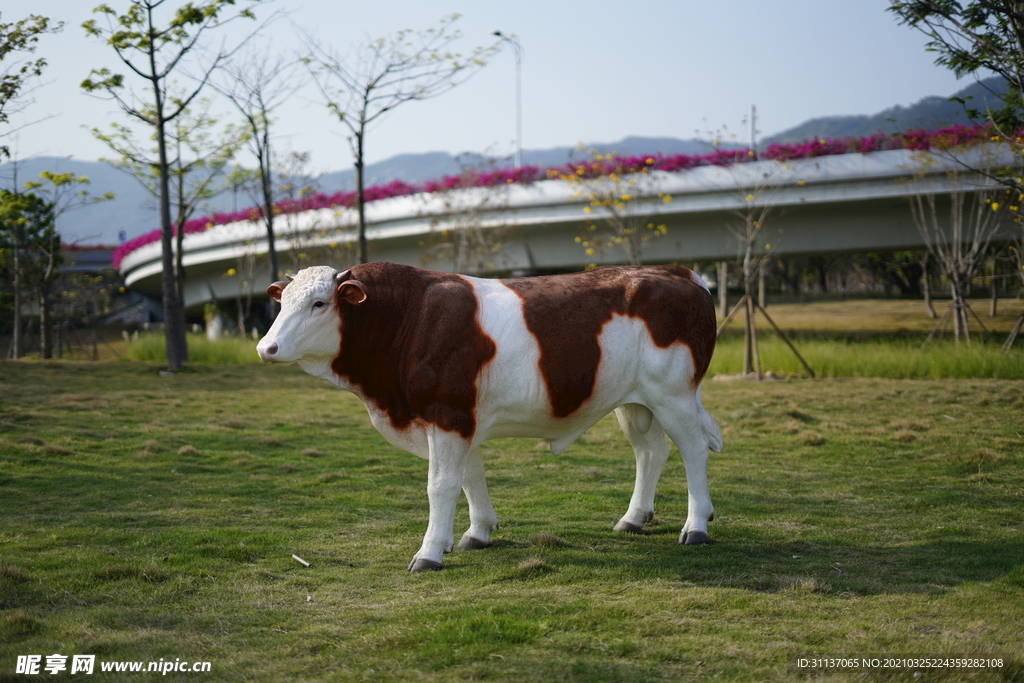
[2,0,983,172]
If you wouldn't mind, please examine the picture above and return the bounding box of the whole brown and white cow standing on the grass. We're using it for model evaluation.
[257,263,722,571]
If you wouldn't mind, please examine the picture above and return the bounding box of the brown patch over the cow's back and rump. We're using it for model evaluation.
[502,265,715,418]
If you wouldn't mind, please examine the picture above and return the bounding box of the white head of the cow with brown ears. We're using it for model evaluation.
[256,265,368,365]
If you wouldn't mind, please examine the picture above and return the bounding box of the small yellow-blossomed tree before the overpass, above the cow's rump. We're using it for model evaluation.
[560,150,672,265]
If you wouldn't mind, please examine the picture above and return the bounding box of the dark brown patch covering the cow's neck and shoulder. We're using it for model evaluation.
[331,263,496,438]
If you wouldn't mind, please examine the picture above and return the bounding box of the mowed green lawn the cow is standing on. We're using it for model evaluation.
[0,361,1024,683]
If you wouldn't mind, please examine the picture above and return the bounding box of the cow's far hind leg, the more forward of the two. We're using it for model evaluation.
[615,403,669,533]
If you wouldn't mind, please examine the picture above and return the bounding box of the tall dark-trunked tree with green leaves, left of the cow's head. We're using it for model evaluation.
[82,0,258,371]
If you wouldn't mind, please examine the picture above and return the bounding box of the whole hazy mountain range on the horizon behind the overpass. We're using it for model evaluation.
[0,79,999,245]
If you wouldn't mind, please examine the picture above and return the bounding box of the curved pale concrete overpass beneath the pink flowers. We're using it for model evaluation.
[121,145,1012,311]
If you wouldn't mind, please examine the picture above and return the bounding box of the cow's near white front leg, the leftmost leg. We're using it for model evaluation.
[409,428,468,571]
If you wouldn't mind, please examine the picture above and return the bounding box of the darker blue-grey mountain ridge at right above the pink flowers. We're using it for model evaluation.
[764,77,1006,144]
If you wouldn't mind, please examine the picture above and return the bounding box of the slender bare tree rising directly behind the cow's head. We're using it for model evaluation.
[214,48,302,321]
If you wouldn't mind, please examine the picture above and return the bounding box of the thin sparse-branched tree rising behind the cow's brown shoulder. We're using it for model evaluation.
[303,14,501,263]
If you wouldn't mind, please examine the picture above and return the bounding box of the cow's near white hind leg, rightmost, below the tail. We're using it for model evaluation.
[654,396,721,546]
